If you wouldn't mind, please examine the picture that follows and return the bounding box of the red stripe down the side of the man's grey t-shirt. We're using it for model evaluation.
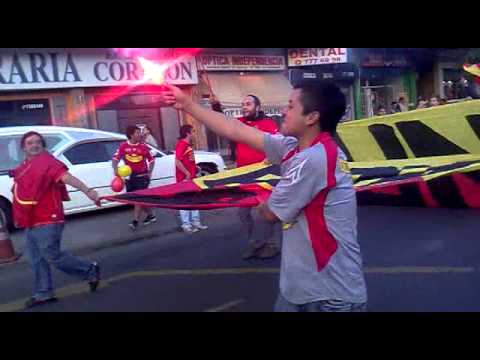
[305,133,338,271]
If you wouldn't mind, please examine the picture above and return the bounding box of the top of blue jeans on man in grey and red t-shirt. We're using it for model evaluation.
[274,294,367,312]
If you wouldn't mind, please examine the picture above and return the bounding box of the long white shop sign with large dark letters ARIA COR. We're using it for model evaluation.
[0,51,198,91]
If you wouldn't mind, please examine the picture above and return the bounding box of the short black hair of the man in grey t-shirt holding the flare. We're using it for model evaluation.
[295,81,347,134]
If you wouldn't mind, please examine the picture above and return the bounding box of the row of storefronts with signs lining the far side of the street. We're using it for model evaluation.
[0,48,469,155]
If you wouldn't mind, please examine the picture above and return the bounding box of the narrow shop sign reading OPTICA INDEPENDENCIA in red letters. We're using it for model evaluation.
[197,55,285,71]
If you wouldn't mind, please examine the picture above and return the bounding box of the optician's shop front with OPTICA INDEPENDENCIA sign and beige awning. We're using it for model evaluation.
[194,48,292,156]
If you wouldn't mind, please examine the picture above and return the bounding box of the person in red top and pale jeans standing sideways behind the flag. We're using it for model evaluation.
[175,125,208,234]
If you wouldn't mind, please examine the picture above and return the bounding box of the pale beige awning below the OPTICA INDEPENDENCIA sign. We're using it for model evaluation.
[203,73,292,108]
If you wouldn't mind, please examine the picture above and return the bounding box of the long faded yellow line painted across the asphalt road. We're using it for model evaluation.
[0,266,475,312]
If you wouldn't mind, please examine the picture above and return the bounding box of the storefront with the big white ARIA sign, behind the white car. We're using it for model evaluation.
[0,48,198,149]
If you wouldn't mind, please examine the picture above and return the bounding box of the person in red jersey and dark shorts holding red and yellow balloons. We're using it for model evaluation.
[112,125,157,231]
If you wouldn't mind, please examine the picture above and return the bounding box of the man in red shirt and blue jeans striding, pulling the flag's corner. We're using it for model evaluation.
[10,131,100,308]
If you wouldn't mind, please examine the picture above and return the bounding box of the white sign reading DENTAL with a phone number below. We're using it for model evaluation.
[288,48,348,66]
